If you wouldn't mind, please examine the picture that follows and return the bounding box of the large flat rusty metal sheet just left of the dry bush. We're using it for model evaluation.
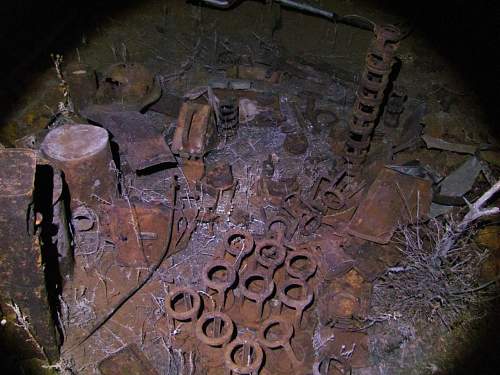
[347,168,432,244]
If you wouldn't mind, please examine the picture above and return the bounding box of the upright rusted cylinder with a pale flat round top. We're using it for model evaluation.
[41,124,117,207]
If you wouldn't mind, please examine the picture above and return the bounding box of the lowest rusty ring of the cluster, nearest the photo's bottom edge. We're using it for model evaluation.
[224,335,264,375]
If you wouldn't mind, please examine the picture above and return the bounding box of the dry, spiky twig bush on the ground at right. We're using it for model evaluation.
[373,220,497,329]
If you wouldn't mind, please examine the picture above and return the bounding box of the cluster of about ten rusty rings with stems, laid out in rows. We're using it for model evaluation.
[165,229,318,374]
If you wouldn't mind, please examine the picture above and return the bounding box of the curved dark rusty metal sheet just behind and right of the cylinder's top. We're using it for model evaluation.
[81,105,176,171]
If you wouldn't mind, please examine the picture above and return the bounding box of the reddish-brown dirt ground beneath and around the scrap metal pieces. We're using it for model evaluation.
[1,0,500,374]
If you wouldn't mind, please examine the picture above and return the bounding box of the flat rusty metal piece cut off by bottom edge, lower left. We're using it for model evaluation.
[98,344,158,375]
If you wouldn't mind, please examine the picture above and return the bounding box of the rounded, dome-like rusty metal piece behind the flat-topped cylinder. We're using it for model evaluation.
[96,63,161,111]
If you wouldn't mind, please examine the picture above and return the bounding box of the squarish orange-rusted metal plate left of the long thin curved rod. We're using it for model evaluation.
[107,201,174,267]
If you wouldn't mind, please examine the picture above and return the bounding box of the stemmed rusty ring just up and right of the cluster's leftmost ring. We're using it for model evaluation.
[201,259,236,310]
